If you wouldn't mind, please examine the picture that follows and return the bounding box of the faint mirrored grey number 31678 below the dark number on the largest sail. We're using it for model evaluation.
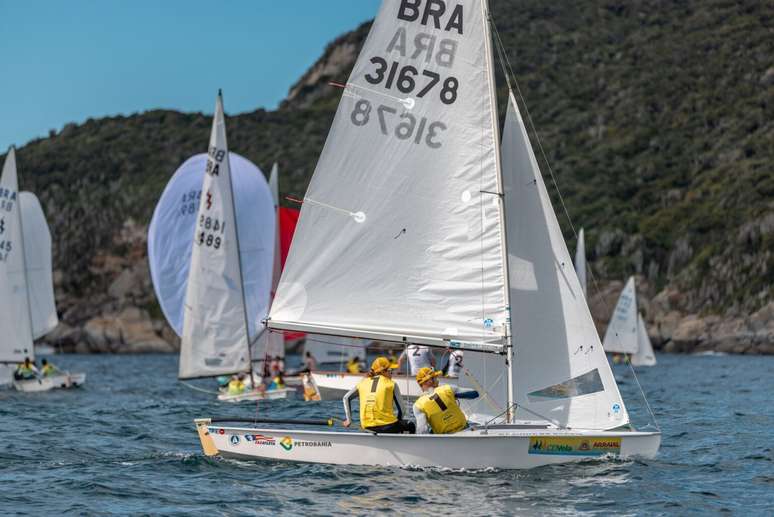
[350,99,446,149]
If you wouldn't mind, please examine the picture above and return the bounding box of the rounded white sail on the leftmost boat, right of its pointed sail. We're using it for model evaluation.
[19,192,59,339]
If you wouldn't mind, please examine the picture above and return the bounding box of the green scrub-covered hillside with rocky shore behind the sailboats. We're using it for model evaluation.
[7,0,774,353]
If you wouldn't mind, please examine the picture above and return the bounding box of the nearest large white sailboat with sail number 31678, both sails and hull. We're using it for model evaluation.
[195,0,661,469]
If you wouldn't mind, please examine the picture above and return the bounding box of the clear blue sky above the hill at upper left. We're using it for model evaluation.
[0,0,380,152]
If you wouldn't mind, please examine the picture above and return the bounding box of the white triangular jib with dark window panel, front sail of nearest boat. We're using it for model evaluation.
[504,94,629,429]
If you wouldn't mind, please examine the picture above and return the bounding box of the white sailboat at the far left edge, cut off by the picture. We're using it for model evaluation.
[0,147,86,391]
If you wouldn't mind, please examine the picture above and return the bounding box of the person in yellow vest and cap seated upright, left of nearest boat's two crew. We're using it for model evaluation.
[342,357,415,433]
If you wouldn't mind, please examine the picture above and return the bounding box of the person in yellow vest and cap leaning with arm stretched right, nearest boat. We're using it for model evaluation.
[414,367,478,434]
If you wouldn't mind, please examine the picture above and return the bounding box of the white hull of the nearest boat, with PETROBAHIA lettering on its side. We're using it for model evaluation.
[196,419,661,469]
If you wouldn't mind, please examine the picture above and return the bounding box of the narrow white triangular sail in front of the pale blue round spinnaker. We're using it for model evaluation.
[179,90,251,379]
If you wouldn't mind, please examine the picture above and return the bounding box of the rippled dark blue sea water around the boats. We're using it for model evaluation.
[0,355,774,516]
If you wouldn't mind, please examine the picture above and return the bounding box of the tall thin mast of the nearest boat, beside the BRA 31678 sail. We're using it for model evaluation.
[481,0,515,422]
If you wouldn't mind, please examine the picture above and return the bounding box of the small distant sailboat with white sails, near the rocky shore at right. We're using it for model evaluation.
[602,276,656,366]
